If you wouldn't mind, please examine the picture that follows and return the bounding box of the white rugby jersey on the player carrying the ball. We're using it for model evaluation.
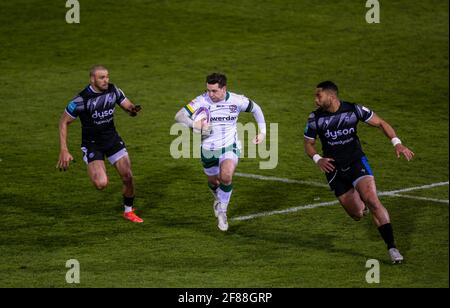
[184,92,254,151]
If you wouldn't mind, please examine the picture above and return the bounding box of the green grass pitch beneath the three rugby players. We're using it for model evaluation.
[0,0,449,288]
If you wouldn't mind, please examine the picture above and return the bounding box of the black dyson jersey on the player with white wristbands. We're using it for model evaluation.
[304,101,373,166]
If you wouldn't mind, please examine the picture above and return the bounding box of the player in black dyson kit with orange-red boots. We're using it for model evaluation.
[56,65,143,223]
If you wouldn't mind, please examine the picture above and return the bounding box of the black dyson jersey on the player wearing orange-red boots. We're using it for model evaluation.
[66,83,126,145]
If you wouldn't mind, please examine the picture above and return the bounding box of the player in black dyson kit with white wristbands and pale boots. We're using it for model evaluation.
[304,81,414,263]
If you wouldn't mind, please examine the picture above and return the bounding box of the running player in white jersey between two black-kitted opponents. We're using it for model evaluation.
[175,73,266,231]
